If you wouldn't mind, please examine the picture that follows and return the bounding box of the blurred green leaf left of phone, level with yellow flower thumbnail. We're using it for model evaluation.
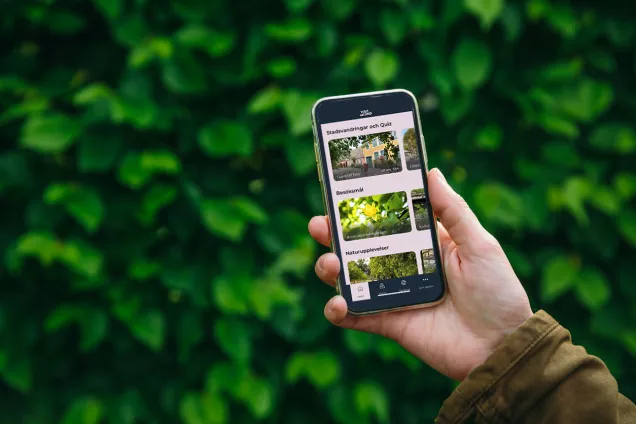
[199,199,247,242]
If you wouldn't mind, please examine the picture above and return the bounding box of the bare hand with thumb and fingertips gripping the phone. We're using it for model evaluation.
[309,169,532,381]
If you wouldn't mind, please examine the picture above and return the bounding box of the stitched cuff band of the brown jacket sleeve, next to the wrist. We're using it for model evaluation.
[435,311,565,423]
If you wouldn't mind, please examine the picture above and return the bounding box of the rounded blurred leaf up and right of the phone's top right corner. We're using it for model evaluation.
[451,39,492,90]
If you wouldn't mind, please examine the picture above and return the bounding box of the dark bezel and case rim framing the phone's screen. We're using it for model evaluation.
[311,89,448,315]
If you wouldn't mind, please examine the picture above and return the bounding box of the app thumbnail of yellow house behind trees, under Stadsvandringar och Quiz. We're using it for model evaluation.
[329,131,402,181]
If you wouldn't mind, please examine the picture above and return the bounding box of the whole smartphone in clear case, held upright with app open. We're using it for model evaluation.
[312,90,448,315]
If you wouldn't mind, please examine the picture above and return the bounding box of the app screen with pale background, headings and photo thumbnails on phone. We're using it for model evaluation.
[320,112,442,302]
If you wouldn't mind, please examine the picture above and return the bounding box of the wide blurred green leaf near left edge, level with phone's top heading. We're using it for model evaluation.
[20,114,82,153]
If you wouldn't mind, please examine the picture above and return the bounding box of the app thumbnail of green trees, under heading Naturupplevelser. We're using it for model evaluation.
[347,252,419,284]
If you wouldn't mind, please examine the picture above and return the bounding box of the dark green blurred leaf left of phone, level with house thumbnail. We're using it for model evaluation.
[198,121,253,158]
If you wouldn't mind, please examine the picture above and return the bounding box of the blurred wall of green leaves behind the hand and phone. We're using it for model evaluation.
[0,0,636,424]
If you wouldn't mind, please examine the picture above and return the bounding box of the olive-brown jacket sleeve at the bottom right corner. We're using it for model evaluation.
[435,311,636,424]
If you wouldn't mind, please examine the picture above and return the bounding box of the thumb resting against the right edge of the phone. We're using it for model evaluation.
[428,168,490,250]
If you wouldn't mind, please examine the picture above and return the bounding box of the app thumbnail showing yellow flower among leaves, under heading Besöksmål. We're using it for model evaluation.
[338,191,411,241]
